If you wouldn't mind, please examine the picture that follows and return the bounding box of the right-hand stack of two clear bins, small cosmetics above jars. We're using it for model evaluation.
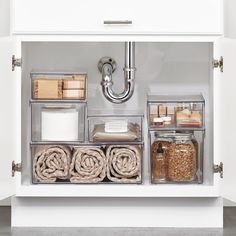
[148,95,205,184]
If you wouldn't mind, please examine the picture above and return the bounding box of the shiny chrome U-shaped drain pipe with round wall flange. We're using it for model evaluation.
[98,42,136,104]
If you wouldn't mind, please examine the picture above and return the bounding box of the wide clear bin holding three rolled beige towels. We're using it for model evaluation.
[31,143,143,184]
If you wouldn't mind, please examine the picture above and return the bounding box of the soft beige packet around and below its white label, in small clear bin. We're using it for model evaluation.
[92,123,140,142]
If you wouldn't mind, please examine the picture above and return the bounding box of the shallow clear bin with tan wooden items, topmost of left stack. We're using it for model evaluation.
[31,72,87,101]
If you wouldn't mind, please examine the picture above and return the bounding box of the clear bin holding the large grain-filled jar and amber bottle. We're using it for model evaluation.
[150,131,204,184]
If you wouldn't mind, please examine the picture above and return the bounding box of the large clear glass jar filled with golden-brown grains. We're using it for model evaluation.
[167,133,197,182]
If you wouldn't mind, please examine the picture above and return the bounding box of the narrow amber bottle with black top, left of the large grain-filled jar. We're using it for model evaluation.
[151,133,173,183]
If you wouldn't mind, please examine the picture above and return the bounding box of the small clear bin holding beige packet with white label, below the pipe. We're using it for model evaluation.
[88,114,143,143]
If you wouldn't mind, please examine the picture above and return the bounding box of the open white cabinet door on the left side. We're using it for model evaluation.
[0,38,17,200]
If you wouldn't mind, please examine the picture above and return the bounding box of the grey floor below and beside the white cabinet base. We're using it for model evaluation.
[0,207,236,236]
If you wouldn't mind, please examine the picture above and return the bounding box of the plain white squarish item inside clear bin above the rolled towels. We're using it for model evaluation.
[41,109,79,141]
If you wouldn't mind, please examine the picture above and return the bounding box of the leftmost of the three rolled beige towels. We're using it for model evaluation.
[33,145,71,183]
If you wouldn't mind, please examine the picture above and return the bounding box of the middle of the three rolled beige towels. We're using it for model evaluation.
[70,147,107,183]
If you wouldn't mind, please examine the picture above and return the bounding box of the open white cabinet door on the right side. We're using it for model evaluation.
[214,38,236,202]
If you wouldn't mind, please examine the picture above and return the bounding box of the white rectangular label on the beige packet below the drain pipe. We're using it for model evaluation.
[105,120,128,133]
